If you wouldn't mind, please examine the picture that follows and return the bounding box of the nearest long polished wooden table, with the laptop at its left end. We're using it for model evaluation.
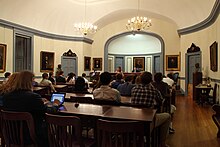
[59,102,156,146]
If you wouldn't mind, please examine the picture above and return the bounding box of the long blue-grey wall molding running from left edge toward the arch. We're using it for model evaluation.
[0,19,93,44]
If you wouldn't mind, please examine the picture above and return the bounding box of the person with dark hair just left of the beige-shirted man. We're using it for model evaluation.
[74,76,89,93]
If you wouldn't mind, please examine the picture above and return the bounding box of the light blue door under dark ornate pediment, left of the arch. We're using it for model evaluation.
[61,56,78,76]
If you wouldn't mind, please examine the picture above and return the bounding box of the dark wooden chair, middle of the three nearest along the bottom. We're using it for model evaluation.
[46,114,95,147]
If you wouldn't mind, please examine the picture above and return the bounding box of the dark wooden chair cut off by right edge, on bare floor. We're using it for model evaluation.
[212,104,220,138]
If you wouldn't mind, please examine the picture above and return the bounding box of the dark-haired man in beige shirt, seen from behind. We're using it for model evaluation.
[93,72,121,102]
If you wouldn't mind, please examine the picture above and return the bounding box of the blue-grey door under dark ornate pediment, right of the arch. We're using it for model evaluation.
[188,55,201,84]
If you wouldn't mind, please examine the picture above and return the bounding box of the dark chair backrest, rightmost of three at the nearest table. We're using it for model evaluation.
[97,119,145,147]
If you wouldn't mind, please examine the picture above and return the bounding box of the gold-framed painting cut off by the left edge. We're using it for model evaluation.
[0,44,7,73]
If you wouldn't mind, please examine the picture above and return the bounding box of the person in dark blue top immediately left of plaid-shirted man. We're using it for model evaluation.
[117,76,135,96]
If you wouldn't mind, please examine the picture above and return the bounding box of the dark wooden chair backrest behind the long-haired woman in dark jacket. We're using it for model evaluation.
[1,110,37,146]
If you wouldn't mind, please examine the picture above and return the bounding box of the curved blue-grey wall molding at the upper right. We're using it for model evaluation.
[177,0,220,36]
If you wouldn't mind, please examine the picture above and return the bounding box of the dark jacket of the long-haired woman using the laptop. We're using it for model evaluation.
[3,90,58,146]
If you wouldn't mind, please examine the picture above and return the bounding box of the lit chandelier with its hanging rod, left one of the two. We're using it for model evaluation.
[74,0,98,36]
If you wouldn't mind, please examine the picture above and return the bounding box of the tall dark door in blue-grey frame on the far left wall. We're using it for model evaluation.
[15,34,32,72]
